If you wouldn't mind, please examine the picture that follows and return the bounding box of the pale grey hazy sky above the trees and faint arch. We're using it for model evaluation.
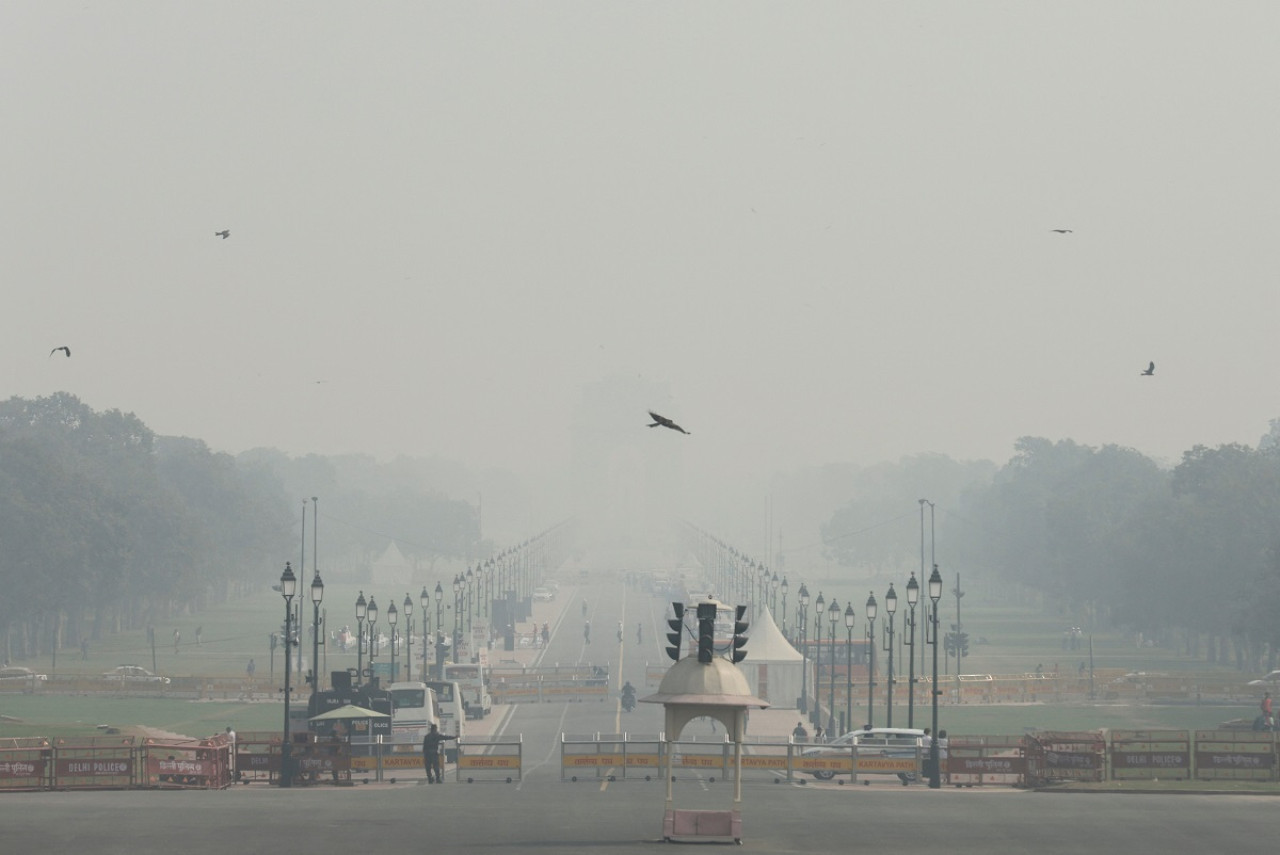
[0,0,1280,483]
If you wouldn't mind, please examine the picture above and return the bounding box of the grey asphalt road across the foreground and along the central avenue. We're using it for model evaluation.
[0,577,1275,855]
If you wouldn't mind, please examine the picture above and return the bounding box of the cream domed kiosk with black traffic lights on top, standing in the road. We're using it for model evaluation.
[640,603,769,843]
